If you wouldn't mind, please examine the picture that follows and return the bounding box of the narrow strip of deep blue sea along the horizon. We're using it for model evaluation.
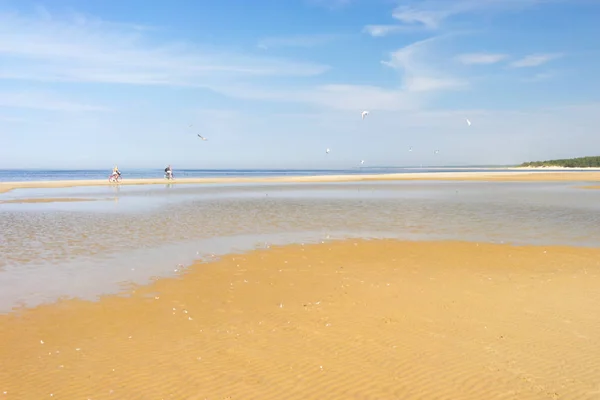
[0,167,580,182]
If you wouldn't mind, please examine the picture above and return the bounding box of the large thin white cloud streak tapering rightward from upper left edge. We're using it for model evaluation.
[0,9,329,86]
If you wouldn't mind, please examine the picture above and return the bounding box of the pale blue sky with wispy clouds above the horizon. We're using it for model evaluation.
[0,0,600,172]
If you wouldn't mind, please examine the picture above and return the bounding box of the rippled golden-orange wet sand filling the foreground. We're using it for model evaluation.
[0,240,600,400]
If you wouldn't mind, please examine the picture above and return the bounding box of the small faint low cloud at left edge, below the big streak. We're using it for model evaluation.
[0,91,109,112]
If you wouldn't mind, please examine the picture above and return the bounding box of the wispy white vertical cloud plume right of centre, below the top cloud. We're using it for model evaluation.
[382,37,467,92]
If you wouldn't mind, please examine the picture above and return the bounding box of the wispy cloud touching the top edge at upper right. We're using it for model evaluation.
[364,0,567,36]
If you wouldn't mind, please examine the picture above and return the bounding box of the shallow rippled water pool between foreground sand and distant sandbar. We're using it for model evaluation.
[0,178,600,312]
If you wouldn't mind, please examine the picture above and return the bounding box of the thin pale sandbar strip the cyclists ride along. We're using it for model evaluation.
[0,171,600,193]
